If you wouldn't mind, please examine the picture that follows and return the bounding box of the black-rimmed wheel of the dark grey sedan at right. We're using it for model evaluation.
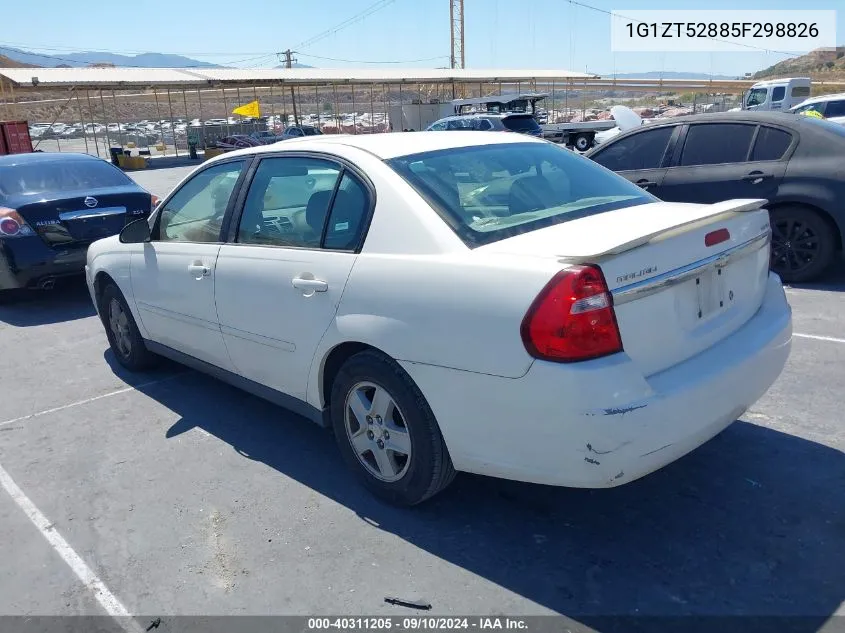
[770,206,836,283]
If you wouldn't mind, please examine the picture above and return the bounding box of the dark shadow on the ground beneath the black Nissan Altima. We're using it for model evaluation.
[0,276,96,327]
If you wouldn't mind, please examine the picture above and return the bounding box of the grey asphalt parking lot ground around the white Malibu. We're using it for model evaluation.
[0,168,845,631]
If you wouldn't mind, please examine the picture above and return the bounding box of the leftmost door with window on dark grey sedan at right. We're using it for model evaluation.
[590,125,681,198]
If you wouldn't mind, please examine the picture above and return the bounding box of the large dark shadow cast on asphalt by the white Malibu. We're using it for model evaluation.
[118,372,845,631]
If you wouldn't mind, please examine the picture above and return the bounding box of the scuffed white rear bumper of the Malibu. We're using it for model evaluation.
[402,275,792,488]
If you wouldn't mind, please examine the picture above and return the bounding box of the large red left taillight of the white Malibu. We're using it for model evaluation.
[520,265,622,363]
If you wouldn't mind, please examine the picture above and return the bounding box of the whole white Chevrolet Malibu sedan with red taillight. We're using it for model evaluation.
[86,132,792,505]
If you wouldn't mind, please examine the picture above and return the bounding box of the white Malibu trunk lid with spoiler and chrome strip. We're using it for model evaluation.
[478,200,771,376]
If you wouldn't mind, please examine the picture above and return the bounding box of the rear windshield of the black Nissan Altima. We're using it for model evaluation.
[0,160,132,196]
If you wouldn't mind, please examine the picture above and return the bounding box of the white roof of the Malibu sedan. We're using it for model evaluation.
[209,131,546,162]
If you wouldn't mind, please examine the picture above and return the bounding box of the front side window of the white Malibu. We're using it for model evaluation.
[158,160,245,242]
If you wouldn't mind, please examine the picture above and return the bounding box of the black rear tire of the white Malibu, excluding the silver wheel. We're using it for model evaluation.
[330,350,456,506]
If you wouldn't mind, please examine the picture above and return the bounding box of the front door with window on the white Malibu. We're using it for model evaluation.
[130,160,246,370]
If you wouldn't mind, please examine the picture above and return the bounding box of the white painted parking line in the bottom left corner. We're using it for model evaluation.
[0,466,144,633]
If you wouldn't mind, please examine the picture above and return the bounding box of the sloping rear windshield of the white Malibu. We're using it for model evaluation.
[386,143,657,247]
